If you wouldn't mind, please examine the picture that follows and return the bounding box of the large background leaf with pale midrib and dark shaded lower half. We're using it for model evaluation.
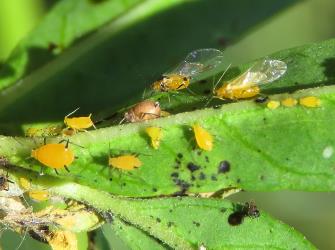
[0,0,296,122]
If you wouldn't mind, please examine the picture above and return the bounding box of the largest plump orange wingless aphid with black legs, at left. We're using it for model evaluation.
[31,141,75,173]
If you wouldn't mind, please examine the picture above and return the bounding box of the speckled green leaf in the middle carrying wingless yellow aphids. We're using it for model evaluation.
[0,83,335,197]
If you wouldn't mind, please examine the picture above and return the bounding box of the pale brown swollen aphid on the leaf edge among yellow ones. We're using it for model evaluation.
[122,100,161,122]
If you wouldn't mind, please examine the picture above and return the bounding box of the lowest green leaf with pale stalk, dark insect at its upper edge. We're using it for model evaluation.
[50,183,315,249]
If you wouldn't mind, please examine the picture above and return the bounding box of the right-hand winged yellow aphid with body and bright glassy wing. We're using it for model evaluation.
[213,59,287,100]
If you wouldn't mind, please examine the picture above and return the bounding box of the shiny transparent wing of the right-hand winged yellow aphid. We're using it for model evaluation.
[229,59,287,87]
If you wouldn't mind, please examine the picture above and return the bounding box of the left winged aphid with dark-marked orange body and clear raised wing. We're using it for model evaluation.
[152,48,223,92]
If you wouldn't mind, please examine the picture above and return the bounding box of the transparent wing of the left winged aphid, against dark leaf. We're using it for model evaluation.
[164,48,223,77]
